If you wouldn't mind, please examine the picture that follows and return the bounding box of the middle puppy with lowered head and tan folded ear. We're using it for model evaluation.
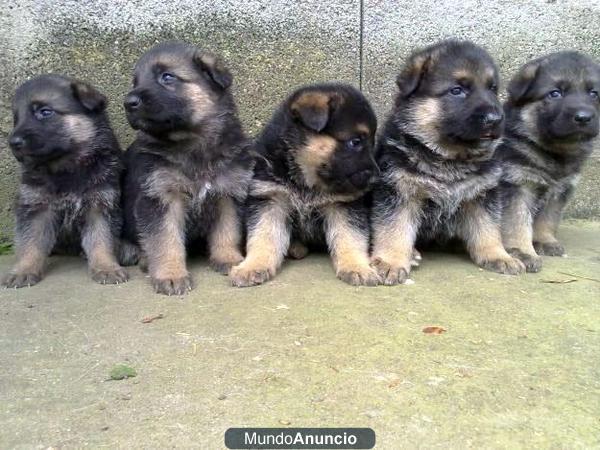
[230,84,378,287]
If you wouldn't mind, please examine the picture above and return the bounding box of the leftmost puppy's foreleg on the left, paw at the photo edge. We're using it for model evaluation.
[0,208,56,288]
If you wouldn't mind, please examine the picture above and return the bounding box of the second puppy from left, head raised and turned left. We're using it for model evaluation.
[124,43,252,295]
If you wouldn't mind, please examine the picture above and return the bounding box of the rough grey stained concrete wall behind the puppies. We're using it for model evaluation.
[0,0,600,240]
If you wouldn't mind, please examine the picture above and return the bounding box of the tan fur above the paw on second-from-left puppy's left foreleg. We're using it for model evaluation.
[142,197,188,280]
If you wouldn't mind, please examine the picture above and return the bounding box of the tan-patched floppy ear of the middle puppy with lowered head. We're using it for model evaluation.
[290,91,337,133]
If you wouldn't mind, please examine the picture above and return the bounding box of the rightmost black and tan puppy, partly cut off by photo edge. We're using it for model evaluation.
[496,52,600,272]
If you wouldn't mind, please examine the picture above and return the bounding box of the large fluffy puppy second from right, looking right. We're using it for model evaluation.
[372,40,524,285]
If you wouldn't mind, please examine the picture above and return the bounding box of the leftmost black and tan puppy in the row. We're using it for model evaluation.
[2,75,128,288]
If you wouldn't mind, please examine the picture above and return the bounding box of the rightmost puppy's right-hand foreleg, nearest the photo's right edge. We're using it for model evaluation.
[533,195,565,256]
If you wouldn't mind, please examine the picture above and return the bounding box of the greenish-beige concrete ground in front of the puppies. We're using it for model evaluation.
[0,222,600,449]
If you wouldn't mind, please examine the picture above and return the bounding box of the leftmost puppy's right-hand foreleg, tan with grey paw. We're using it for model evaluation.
[81,208,129,284]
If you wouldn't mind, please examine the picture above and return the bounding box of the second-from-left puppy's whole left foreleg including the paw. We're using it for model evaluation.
[141,196,193,295]
